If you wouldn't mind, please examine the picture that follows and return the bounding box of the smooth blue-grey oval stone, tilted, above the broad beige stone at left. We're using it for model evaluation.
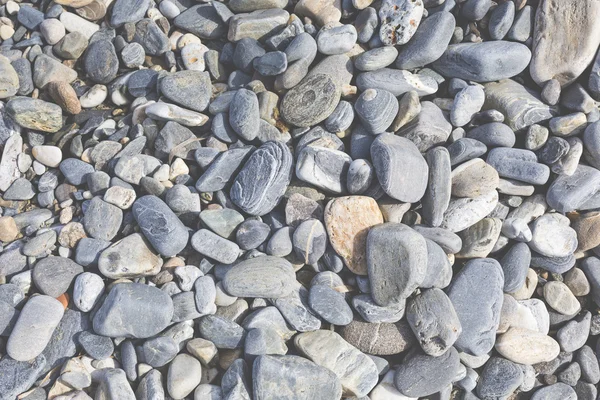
[132,195,189,256]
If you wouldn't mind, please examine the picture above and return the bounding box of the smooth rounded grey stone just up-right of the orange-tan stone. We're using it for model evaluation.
[371,134,429,203]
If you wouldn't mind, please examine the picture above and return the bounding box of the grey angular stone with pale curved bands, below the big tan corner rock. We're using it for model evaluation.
[483,79,558,132]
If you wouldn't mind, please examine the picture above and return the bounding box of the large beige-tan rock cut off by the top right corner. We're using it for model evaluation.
[529,0,600,86]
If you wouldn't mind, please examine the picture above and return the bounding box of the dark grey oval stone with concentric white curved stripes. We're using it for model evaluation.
[230,142,293,215]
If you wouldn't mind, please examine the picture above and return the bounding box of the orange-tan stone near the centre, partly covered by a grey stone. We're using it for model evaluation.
[325,196,383,275]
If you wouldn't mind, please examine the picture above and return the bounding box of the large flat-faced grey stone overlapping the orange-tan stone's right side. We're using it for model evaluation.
[367,223,427,306]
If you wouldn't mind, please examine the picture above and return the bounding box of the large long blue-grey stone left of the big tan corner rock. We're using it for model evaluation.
[432,40,531,82]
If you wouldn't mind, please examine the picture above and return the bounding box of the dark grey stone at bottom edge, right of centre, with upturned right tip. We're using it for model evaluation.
[394,348,460,397]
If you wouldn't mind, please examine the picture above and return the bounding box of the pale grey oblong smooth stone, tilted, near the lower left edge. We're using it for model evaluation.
[6,295,64,361]
